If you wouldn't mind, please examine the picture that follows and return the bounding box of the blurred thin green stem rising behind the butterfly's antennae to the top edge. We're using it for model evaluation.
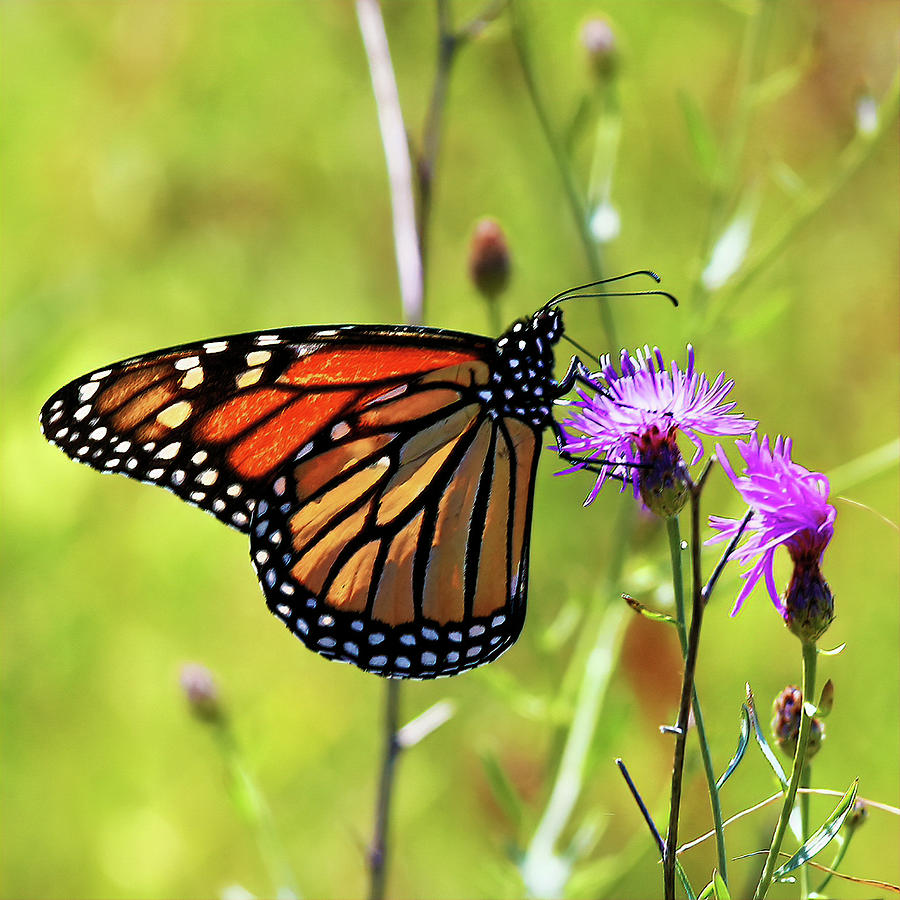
[509,0,619,347]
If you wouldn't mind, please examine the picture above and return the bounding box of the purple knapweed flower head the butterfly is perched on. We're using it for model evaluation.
[562,344,756,517]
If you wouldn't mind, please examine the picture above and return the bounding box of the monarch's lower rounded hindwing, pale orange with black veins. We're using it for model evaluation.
[251,363,539,678]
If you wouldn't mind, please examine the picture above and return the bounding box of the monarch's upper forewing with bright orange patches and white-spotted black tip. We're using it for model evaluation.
[41,326,491,531]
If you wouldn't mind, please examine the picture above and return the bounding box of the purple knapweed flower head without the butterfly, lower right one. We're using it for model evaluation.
[707,434,836,641]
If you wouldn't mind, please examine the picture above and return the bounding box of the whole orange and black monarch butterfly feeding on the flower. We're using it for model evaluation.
[41,273,674,678]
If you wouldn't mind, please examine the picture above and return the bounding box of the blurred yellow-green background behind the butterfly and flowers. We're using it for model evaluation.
[0,0,900,898]
